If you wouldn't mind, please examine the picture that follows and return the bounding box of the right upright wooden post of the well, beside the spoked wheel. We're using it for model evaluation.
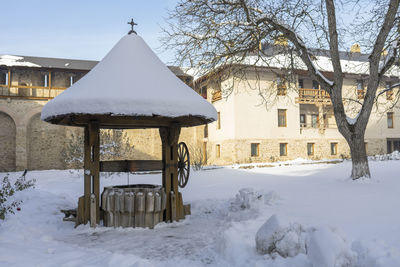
[159,125,181,221]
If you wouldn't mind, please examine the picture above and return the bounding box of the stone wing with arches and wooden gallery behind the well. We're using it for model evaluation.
[0,55,202,171]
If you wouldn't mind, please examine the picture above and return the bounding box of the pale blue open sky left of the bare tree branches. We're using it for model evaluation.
[0,0,177,63]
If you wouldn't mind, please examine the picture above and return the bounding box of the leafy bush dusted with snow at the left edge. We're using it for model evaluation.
[0,172,36,220]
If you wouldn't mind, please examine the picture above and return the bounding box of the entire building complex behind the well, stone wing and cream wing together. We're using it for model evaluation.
[0,43,400,171]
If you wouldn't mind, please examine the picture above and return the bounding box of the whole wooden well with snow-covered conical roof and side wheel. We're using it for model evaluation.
[41,22,217,227]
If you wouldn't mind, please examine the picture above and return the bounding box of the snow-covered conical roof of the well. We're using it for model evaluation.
[41,34,217,128]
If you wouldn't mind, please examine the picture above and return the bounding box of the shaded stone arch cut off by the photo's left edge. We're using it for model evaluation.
[0,111,16,172]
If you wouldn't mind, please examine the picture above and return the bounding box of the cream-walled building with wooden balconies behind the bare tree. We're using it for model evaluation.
[195,45,400,164]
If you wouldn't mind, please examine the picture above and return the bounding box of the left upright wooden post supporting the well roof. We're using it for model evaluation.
[83,122,100,225]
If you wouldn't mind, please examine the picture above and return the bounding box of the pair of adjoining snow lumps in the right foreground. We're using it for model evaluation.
[256,215,356,267]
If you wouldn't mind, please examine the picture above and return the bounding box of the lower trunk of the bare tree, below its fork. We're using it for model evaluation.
[346,134,371,180]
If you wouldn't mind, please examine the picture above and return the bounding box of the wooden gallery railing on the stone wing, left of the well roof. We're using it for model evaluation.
[0,85,67,100]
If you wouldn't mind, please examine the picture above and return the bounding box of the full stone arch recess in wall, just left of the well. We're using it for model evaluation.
[26,113,66,170]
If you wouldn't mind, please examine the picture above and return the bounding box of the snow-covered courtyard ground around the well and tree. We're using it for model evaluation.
[0,160,400,267]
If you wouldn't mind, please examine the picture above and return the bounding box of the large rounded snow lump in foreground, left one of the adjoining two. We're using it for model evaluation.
[256,215,307,258]
